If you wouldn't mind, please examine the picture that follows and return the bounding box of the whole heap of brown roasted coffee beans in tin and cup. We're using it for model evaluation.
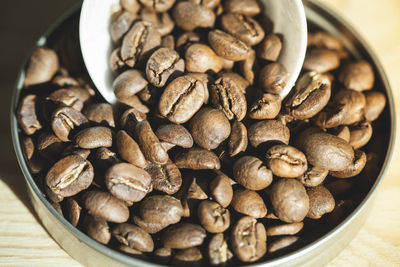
[16,0,386,266]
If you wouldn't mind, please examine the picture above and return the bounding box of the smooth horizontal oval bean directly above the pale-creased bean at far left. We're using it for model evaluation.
[74,126,113,149]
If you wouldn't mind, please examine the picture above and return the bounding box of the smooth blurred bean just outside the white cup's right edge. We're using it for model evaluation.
[303,48,340,73]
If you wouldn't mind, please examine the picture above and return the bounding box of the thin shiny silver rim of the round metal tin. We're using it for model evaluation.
[10,0,397,266]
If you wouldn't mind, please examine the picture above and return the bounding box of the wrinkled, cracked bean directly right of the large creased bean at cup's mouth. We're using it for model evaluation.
[210,72,249,121]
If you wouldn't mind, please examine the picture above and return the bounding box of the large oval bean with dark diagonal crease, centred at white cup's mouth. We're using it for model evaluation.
[158,75,205,124]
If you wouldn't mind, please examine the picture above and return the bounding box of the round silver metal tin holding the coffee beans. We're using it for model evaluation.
[11,0,395,266]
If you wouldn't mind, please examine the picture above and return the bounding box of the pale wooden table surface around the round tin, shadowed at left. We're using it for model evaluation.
[0,0,400,267]
